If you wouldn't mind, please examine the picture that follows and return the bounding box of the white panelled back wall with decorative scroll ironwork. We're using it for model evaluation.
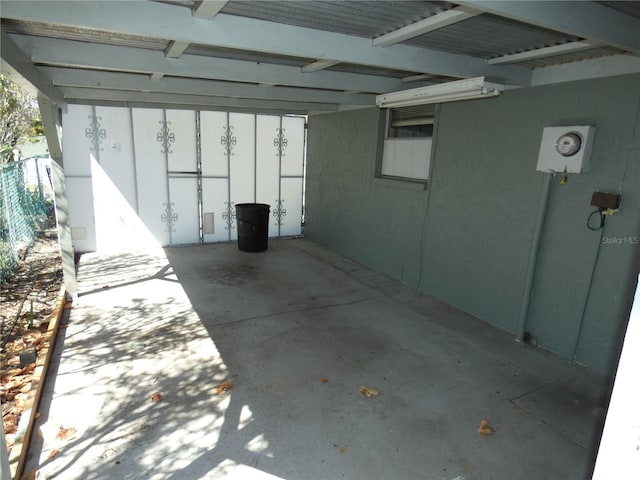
[63,105,305,252]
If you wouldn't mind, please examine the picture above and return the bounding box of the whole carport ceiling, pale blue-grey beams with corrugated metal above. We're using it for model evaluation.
[2,0,640,111]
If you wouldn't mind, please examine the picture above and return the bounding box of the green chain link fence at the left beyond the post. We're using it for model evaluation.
[0,157,53,283]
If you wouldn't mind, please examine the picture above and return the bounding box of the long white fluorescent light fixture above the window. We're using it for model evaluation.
[376,77,504,108]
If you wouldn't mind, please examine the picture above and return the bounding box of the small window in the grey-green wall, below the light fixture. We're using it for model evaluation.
[377,105,435,182]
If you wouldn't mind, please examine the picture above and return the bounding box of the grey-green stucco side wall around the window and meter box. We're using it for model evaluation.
[305,75,640,372]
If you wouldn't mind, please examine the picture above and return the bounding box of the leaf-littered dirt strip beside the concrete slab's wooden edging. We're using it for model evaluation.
[0,230,62,458]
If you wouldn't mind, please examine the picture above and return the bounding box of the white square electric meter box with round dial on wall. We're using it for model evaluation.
[536,125,596,173]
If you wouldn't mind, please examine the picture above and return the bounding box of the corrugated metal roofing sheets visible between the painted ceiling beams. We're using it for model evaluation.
[2,0,624,72]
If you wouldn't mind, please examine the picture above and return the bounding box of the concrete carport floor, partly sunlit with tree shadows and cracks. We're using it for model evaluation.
[27,240,609,480]
